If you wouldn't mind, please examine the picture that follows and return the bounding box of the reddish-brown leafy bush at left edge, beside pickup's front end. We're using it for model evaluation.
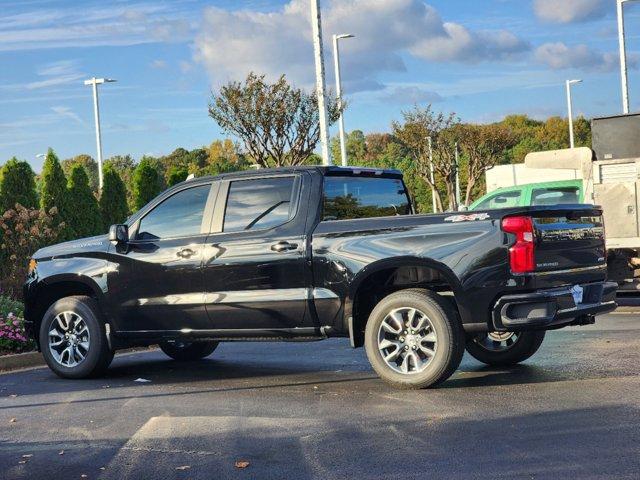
[0,204,65,298]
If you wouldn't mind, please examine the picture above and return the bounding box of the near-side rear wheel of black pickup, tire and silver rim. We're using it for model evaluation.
[365,289,464,389]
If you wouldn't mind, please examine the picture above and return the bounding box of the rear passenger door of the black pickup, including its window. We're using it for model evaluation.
[203,173,311,330]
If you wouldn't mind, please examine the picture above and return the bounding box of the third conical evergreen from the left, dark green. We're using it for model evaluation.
[68,164,103,237]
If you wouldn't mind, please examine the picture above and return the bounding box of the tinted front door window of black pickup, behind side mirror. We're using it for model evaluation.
[137,185,211,240]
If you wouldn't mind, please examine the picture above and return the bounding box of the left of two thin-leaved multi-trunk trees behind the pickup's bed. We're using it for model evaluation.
[392,105,460,211]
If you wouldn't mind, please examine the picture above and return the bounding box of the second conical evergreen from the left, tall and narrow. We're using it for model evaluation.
[40,148,74,240]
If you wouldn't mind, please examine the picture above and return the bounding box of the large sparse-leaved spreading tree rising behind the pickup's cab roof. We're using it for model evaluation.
[209,73,339,167]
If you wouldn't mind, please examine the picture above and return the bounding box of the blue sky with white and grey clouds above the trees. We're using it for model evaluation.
[0,0,640,171]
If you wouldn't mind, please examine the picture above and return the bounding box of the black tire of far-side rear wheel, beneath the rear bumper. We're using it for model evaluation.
[467,330,546,366]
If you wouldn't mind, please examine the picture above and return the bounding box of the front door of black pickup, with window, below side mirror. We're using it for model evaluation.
[109,183,213,332]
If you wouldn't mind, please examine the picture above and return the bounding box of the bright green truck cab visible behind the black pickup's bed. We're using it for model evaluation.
[469,180,584,210]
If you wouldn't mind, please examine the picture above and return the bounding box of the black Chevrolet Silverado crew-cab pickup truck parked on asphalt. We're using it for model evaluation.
[24,167,616,388]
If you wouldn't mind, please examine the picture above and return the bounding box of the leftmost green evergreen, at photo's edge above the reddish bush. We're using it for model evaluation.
[0,157,38,213]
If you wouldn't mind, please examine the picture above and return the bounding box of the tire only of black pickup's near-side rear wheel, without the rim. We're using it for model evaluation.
[365,289,465,389]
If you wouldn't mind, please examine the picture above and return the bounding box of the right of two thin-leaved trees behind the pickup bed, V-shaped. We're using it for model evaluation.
[458,124,517,205]
